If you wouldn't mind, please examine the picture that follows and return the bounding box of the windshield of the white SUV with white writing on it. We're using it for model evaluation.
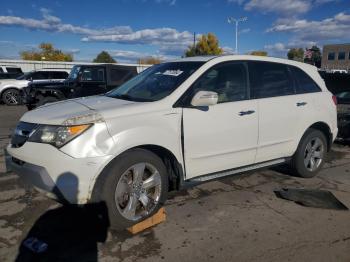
[106,62,204,102]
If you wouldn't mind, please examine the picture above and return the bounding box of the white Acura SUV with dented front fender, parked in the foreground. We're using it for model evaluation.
[6,55,338,228]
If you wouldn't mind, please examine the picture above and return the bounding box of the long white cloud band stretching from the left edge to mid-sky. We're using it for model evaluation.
[0,9,193,53]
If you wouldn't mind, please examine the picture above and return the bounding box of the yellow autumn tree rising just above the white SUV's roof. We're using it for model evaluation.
[185,33,223,57]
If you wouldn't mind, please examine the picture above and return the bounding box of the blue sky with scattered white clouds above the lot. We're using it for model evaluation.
[0,0,350,62]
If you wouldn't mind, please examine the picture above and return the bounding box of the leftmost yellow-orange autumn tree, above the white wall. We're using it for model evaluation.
[20,43,73,62]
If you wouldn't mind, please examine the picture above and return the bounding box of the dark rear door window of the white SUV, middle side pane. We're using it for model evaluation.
[249,62,295,99]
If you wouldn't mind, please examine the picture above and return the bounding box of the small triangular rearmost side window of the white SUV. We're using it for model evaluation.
[290,66,321,94]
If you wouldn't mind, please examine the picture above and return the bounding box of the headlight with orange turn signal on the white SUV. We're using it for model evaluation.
[28,124,92,148]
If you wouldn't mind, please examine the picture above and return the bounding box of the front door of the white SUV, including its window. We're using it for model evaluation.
[183,62,258,179]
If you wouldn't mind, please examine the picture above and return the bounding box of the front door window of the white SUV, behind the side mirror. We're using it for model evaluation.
[186,62,248,103]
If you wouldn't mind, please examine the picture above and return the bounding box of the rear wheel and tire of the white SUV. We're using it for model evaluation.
[291,128,328,178]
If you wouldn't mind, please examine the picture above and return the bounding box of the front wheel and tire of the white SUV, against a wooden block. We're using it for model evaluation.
[93,149,168,230]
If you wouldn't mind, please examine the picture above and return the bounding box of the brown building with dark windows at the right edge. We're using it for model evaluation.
[321,44,350,72]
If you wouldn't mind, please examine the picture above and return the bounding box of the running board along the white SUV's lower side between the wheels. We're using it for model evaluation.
[185,158,287,183]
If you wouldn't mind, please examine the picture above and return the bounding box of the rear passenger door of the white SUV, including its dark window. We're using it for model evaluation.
[249,61,298,163]
